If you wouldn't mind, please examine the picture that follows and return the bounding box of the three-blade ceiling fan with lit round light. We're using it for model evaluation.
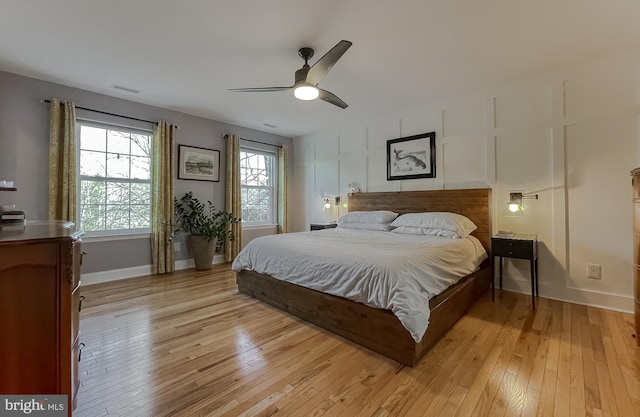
[229,40,352,109]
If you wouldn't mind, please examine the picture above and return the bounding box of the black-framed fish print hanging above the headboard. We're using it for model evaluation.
[387,132,436,181]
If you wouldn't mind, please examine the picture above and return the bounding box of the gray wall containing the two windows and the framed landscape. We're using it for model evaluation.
[0,72,293,273]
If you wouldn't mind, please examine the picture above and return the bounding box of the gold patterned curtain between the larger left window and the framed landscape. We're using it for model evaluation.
[151,121,175,274]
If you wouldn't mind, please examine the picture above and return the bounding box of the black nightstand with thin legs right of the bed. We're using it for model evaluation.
[491,234,538,310]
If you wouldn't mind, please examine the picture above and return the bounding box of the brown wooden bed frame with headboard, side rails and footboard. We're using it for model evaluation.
[237,188,493,366]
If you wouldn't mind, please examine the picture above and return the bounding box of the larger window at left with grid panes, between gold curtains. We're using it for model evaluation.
[77,120,151,234]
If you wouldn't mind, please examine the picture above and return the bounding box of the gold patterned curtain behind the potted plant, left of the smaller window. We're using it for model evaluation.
[224,135,242,262]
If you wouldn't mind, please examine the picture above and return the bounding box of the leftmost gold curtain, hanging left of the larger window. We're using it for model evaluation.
[49,98,77,222]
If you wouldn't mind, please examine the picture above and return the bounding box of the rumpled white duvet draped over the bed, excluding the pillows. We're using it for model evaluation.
[232,228,487,342]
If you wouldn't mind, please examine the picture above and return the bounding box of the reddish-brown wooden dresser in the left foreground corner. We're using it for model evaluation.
[0,221,82,416]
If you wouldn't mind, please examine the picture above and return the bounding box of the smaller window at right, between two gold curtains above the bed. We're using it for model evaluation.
[240,148,278,225]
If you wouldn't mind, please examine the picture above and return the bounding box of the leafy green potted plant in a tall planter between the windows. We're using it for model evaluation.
[174,191,240,271]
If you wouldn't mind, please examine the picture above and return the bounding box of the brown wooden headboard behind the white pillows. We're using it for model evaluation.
[348,188,492,254]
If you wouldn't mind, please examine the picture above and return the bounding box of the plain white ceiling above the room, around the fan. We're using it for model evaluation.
[0,0,640,137]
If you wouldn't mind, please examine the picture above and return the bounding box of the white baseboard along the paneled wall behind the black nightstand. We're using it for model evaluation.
[504,279,634,314]
